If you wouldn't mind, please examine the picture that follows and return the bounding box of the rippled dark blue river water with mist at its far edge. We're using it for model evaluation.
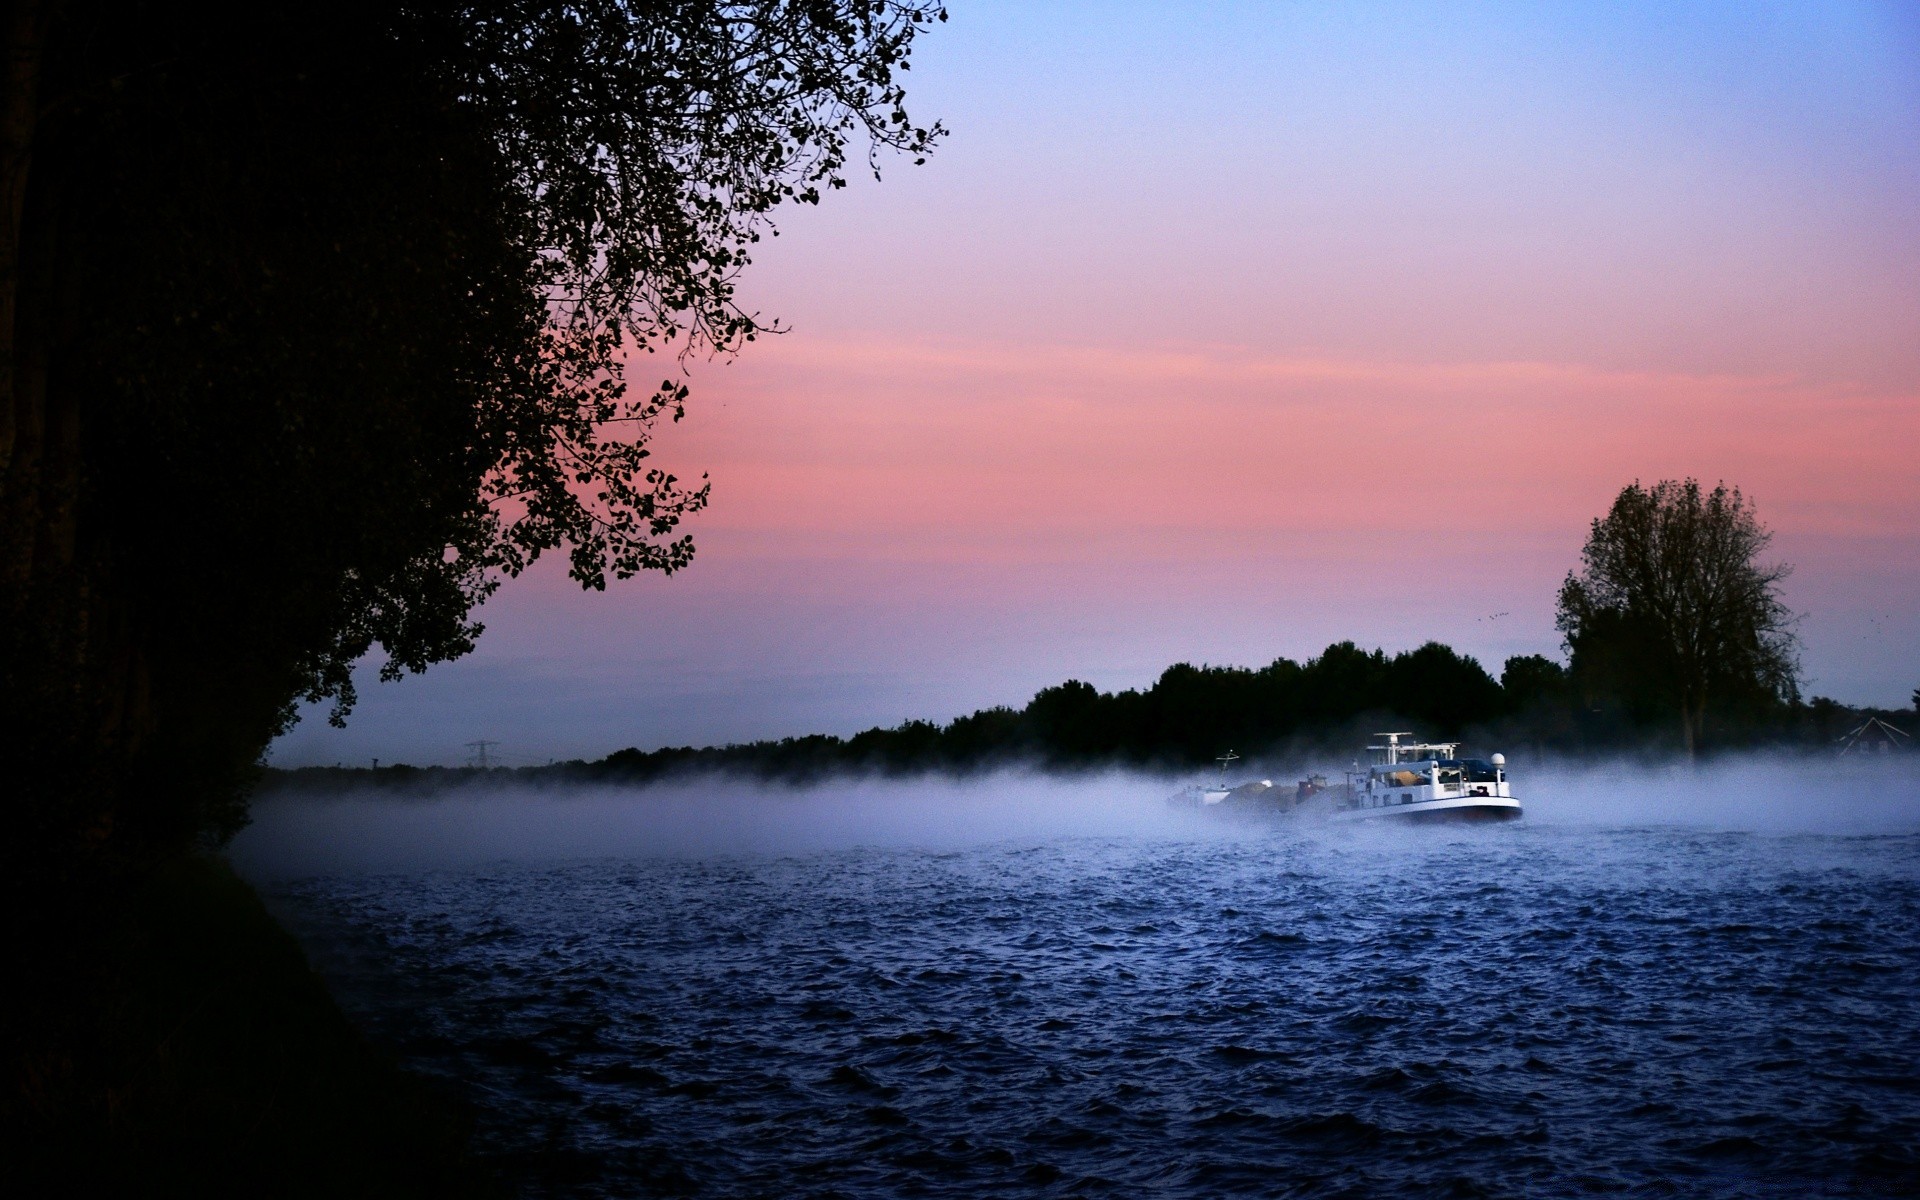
[240,772,1920,1198]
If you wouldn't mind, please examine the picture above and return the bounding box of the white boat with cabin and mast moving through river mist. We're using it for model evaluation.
[1329,732,1521,822]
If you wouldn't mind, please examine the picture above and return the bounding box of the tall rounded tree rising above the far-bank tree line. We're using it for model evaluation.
[1557,480,1799,755]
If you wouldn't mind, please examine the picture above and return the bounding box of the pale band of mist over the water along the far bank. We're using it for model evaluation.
[232,756,1920,879]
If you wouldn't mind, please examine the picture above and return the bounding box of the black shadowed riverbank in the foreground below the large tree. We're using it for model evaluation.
[0,856,505,1198]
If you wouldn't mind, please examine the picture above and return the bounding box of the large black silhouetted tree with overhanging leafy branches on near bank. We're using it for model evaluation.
[0,0,943,860]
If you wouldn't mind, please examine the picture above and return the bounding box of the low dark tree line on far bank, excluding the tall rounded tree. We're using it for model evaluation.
[271,641,1920,791]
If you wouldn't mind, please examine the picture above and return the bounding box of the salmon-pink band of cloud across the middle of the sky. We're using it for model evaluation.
[672,334,1920,549]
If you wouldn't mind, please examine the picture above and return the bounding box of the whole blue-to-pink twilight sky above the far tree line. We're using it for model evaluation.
[271,0,1920,766]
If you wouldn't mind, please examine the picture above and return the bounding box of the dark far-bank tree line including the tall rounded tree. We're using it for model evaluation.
[282,478,1920,783]
